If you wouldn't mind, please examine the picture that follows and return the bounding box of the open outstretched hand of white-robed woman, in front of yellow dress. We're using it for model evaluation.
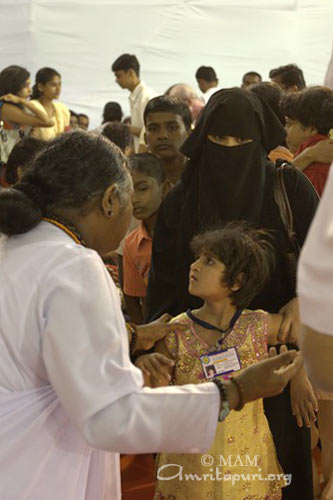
[233,346,302,407]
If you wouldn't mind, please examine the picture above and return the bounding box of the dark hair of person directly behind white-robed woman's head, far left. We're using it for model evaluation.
[5,137,47,184]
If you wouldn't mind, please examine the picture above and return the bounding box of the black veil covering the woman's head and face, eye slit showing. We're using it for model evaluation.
[182,88,285,230]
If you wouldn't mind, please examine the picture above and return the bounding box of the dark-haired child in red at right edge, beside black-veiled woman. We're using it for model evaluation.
[282,87,333,196]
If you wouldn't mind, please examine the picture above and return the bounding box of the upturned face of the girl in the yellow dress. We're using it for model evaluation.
[188,252,239,301]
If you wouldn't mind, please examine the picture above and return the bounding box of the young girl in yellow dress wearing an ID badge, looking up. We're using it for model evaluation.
[145,222,314,500]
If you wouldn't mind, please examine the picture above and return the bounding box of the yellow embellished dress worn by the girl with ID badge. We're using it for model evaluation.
[154,310,289,500]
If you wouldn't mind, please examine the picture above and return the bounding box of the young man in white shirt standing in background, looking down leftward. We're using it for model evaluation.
[111,54,156,152]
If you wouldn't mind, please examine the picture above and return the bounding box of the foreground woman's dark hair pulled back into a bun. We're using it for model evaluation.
[0,131,130,235]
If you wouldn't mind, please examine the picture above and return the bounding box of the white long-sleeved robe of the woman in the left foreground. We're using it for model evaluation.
[0,222,219,500]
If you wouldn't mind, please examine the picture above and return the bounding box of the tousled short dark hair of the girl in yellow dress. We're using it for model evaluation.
[191,221,275,308]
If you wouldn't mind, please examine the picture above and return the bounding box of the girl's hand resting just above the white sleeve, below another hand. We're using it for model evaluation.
[135,353,175,387]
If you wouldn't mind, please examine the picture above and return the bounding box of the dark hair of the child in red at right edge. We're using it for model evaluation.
[281,86,333,135]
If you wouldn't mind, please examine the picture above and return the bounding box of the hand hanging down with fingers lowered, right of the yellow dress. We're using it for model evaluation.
[290,367,318,427]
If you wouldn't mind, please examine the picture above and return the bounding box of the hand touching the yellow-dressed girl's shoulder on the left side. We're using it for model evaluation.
[135,314,186,351]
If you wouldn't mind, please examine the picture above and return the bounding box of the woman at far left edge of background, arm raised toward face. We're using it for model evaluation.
[0,66,53,164]
